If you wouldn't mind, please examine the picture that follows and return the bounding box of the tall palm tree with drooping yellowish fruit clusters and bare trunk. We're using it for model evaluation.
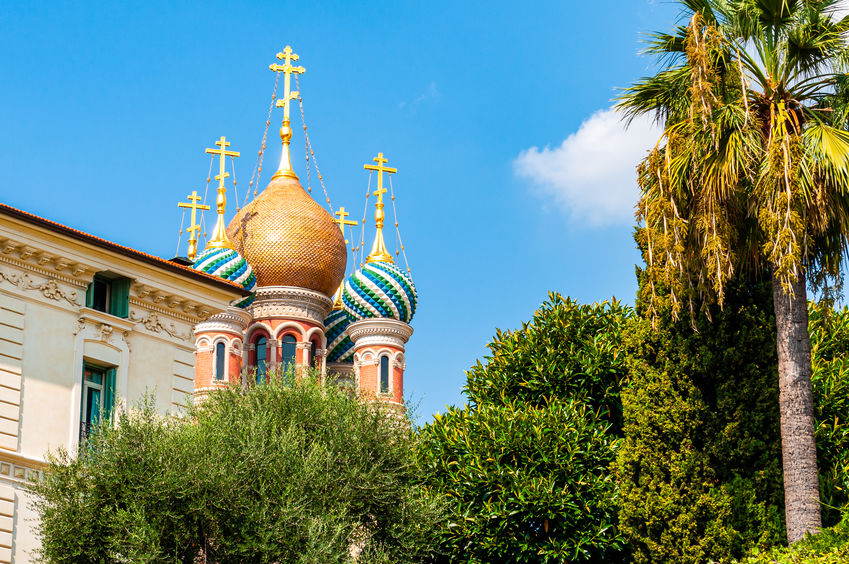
[619,0,849,543]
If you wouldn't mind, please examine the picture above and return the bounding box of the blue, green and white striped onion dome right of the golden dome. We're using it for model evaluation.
[342,261,418,323]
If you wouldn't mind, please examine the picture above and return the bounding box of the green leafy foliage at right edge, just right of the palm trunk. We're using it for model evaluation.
[808,301,849,526]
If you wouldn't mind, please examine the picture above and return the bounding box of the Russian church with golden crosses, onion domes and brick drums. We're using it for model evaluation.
[181,46,417,411]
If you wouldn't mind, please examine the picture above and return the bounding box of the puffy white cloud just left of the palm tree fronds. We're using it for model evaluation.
[513,108,661,226]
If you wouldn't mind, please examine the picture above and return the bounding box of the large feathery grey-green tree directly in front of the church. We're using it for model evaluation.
[33,372,440,564]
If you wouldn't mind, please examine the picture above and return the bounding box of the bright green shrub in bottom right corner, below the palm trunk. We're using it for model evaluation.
[743,513,849,564]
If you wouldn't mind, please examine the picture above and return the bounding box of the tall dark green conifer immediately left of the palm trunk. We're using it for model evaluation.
[618,272,784,563]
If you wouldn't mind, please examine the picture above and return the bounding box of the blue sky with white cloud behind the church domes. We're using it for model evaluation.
[0,0,677,420]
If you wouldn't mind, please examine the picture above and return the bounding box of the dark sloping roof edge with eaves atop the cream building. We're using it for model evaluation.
[0,203,250,296]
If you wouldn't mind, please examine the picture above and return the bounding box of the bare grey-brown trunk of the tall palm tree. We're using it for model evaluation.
[772,273,822,544]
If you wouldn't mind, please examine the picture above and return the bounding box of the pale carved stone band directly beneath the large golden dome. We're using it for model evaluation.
[248,286,333,327]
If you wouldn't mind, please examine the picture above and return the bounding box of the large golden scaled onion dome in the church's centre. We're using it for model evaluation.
[227,174,348,296]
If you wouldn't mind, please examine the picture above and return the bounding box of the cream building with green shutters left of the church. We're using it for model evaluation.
[0,204,247,562]
